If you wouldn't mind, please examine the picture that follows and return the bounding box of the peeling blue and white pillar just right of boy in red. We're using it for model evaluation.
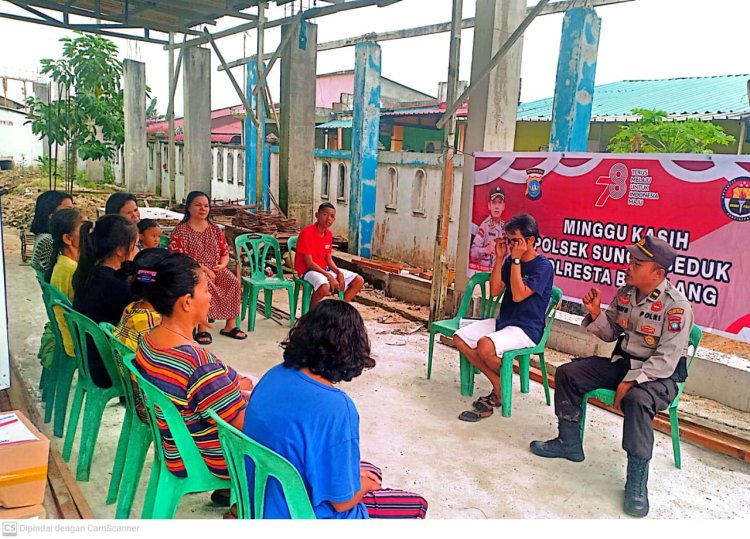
[349,43,381,258]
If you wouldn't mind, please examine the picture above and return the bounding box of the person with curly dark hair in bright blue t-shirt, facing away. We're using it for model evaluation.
[243,301,427,519]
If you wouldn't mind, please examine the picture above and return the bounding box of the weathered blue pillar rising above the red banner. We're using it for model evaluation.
[549,7,602,152]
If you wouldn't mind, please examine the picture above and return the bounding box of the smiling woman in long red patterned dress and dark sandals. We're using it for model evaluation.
[169,191,247,345]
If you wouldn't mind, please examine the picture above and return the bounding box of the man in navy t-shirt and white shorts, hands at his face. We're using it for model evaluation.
[453,213,554,422]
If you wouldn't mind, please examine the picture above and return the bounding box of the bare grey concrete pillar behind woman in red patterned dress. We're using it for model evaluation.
[182,47,213,197]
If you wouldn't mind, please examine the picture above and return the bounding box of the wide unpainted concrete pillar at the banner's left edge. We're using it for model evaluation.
[456,0,526,291]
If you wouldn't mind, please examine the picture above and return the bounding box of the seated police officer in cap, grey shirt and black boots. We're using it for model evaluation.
[531,236,693,517]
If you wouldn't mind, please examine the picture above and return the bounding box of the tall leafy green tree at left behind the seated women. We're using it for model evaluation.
[26,34,125,190]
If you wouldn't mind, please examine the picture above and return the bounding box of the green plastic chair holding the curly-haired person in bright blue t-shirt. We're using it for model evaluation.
[208,410,315,520]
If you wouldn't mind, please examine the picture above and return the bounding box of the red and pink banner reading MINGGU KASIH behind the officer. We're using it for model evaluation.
[470,153,750,342]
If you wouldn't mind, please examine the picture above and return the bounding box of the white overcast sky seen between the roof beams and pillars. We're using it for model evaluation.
[0,0,750,115]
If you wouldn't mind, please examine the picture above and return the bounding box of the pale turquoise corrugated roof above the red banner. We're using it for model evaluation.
[518,74,750,121]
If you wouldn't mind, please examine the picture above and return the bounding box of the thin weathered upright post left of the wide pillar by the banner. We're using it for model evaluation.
[430,0,463,323]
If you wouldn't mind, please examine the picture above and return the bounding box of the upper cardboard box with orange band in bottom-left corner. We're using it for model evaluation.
[0,410,49,509]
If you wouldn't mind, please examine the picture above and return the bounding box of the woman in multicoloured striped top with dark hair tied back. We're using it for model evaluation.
[135,253,252,498]
